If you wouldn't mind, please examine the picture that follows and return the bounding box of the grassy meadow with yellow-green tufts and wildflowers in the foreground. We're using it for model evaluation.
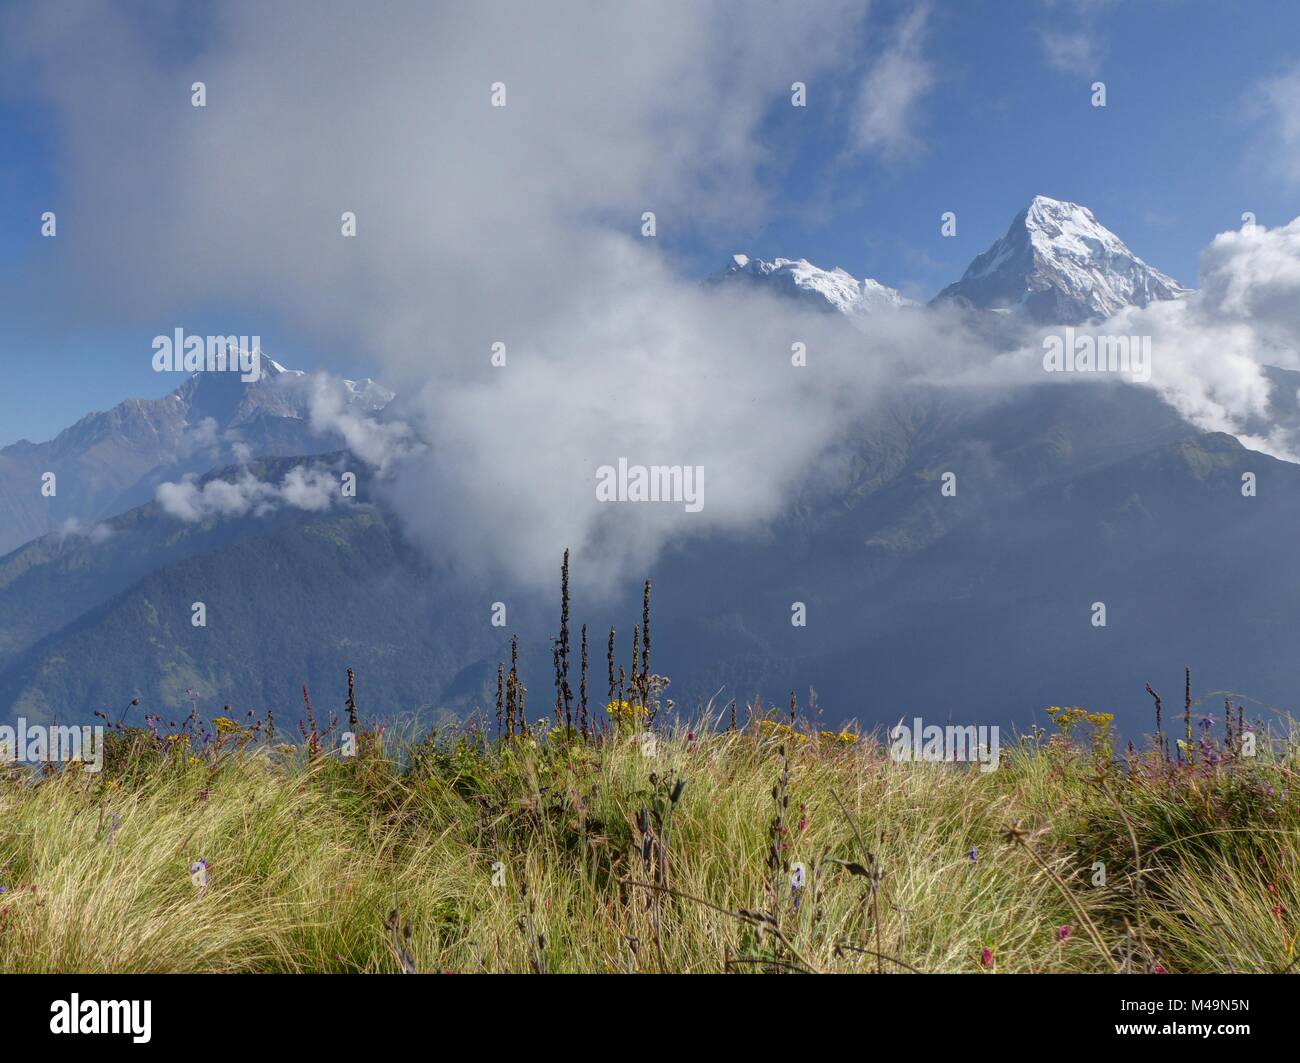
[0,686,1300,975]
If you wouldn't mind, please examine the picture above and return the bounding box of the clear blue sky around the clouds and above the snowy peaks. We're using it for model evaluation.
[0,0,1300,446]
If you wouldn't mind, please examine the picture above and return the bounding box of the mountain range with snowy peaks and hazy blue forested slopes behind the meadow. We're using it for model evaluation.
[0,196,1300,729]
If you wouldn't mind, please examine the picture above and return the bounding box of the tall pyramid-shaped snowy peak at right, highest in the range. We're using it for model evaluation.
[935,195,1188,325]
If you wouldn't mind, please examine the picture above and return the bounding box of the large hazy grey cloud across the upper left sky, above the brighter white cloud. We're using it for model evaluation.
[0,0,863,350]
